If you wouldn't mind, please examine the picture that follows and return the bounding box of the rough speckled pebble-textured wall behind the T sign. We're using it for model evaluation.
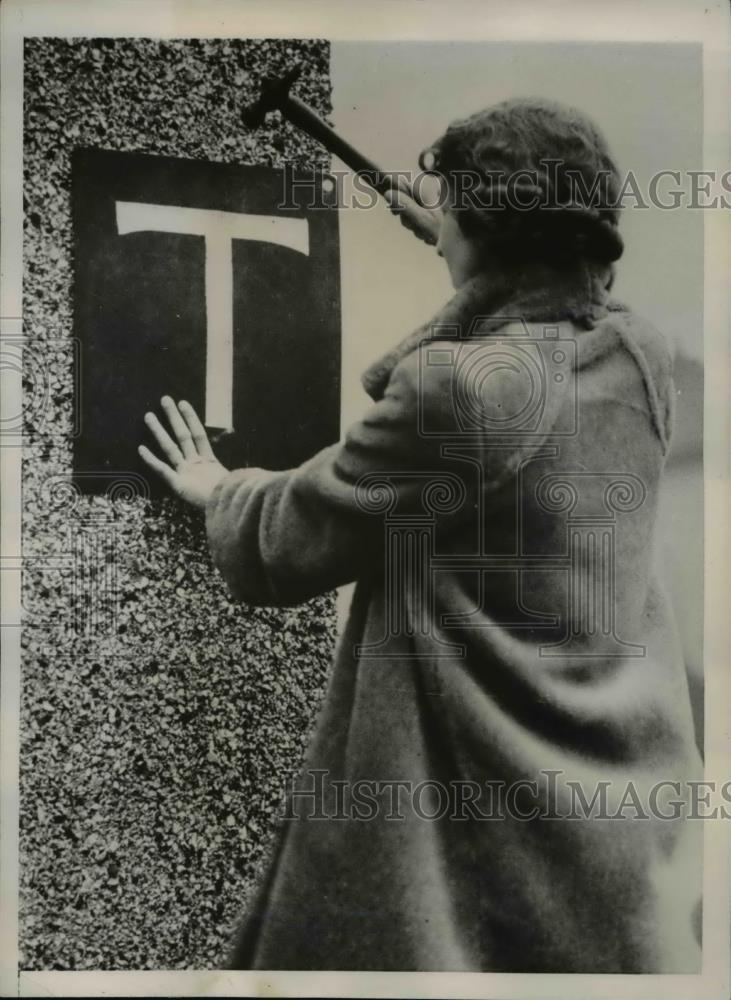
[20,38,335,969]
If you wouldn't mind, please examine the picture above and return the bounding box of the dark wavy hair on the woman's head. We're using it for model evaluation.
[419,98,624,265]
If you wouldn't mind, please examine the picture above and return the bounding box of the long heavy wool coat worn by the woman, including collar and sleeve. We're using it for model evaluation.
[206,267,702,973]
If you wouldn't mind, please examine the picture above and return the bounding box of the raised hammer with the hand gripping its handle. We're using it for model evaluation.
[242,65,439,246]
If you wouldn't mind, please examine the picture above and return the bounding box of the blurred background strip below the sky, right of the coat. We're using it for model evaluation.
[660,354,704,752]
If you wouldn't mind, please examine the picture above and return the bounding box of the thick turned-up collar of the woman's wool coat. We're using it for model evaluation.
[361,264,614,400]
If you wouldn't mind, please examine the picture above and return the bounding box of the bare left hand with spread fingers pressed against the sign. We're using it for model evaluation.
[137,396,228,509]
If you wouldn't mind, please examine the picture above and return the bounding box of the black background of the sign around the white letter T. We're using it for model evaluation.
[72,149,341,493]
